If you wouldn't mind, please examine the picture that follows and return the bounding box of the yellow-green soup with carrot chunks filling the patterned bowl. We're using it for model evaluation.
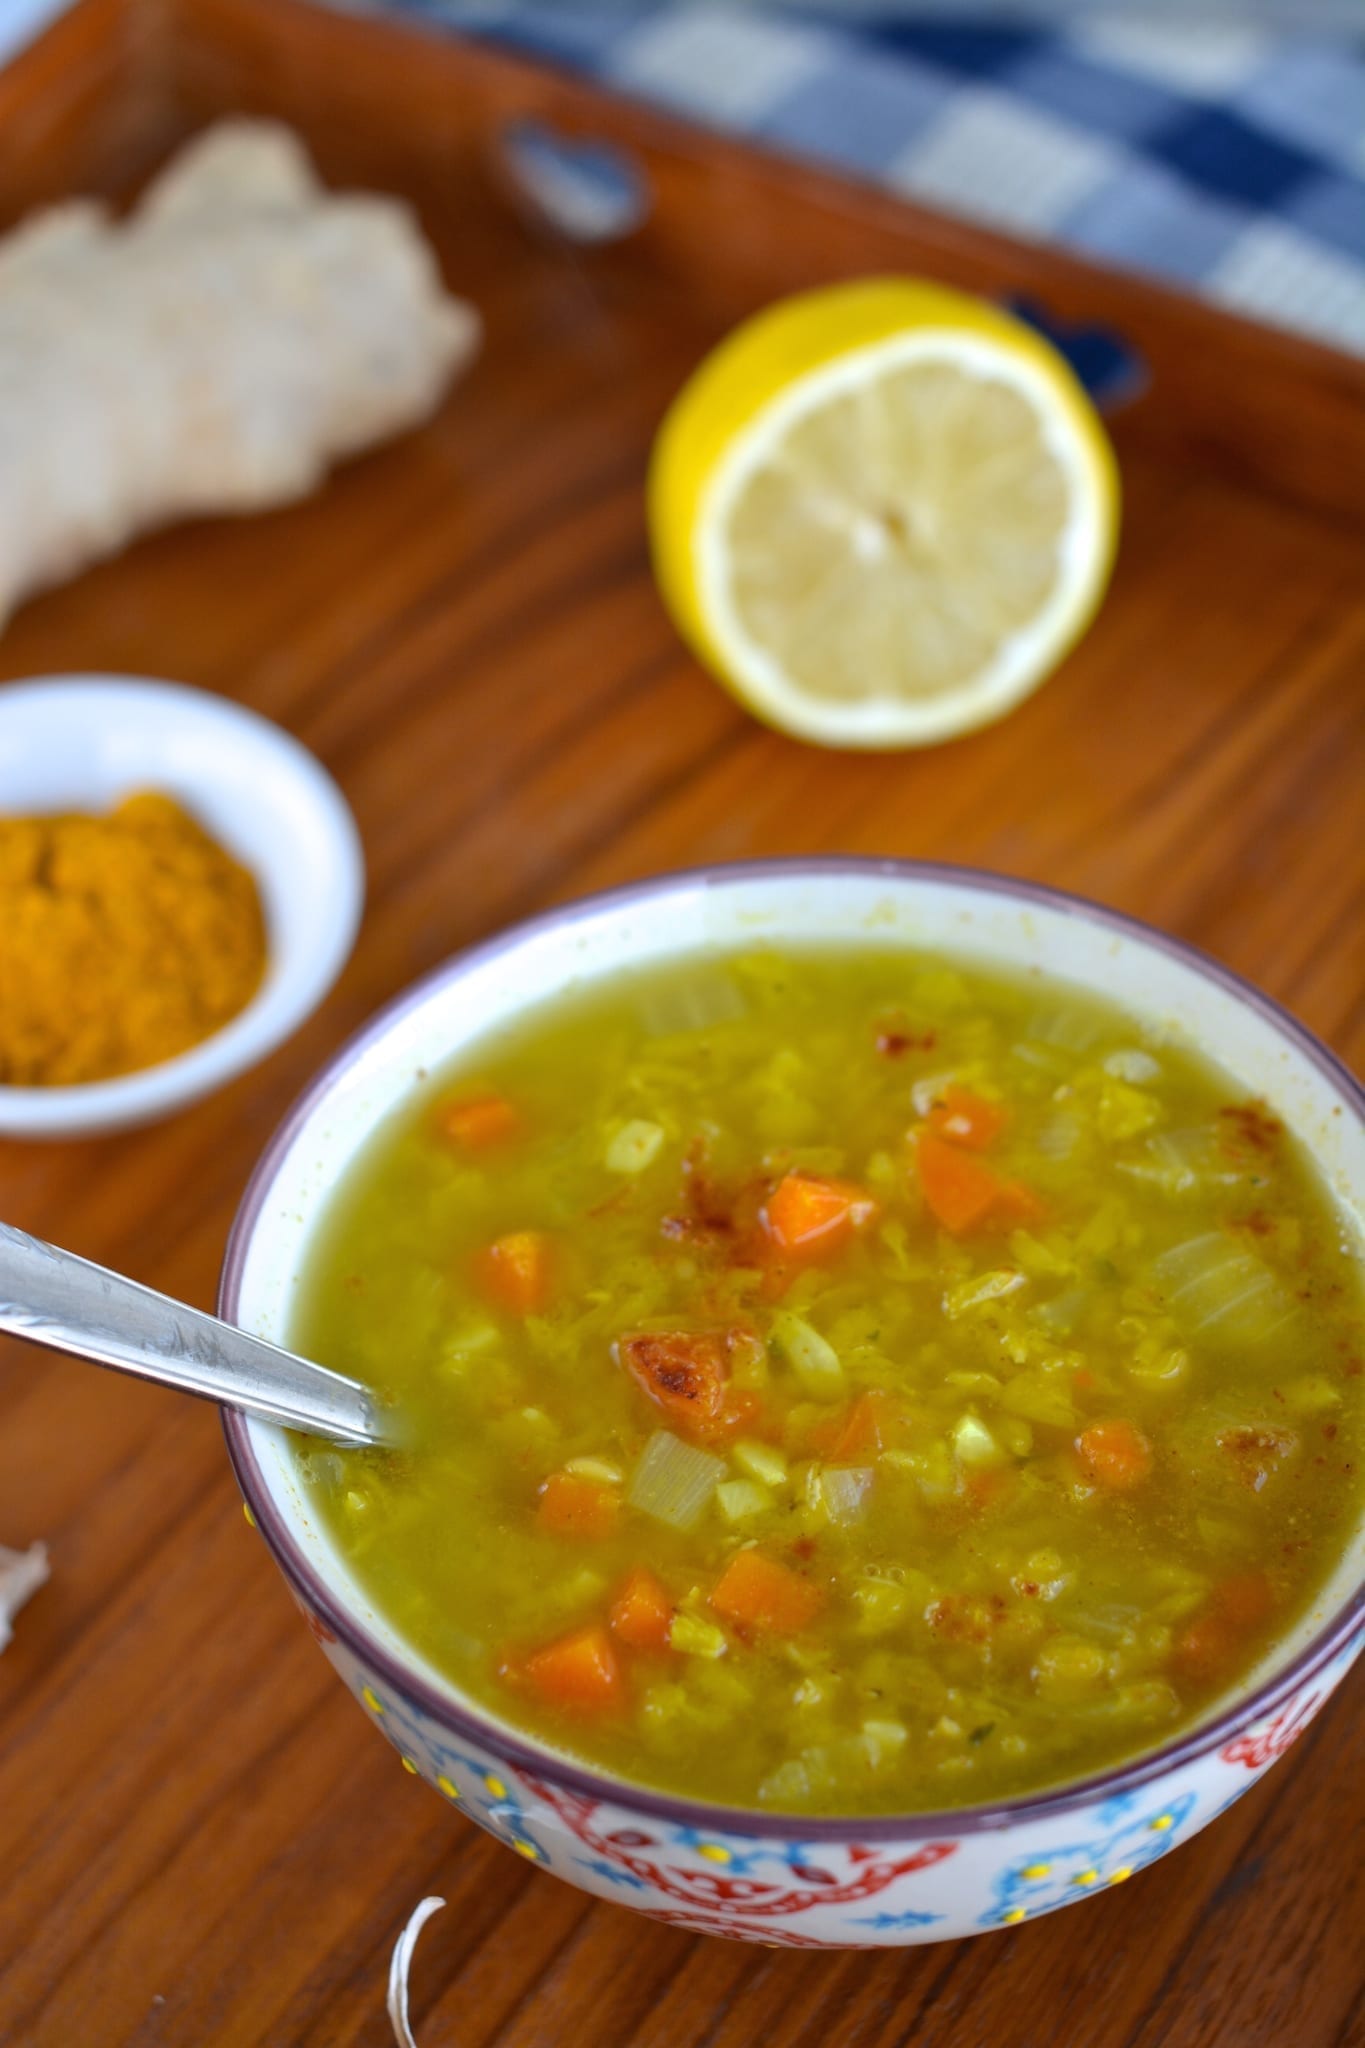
[291,948,1365,1812]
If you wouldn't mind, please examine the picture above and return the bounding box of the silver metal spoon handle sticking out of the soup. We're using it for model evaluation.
[0,1223,387,1444]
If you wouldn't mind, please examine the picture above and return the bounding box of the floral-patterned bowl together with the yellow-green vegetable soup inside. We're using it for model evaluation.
[221,860,1365,1948]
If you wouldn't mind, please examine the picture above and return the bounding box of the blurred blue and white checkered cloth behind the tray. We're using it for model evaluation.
[0,0,1365,356]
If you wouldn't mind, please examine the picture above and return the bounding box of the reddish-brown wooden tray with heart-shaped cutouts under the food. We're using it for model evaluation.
[0,0,1365,2048]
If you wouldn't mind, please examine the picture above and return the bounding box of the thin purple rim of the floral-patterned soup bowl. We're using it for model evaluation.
[217,854,1365,1843]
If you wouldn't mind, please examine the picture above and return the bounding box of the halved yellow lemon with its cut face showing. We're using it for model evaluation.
[649,279,1119,748]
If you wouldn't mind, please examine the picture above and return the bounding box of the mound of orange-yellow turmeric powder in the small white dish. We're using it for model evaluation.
[0,793,266,1087]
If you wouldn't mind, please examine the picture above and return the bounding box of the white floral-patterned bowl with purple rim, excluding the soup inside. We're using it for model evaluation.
[221,860,1365,1948]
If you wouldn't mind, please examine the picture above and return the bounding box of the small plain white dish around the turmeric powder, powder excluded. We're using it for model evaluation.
[0,676,364,1139]
